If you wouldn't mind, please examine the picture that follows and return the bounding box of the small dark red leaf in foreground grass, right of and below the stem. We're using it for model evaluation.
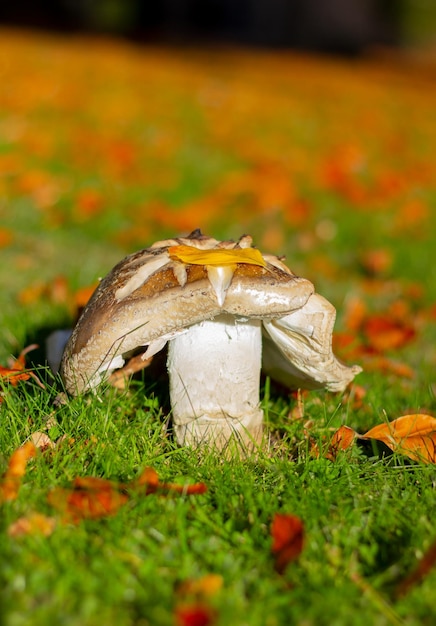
[271,513,304,574]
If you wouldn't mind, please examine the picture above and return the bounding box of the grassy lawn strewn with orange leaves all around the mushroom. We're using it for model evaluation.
[0,30,436,626]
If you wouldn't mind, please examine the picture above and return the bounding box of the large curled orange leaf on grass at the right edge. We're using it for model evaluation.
[361,413,436,463]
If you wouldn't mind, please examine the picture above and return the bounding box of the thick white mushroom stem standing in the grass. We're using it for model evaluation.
[168,315,263,448]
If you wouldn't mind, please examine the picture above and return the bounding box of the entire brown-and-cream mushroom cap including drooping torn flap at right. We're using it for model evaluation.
[60,230,361,395]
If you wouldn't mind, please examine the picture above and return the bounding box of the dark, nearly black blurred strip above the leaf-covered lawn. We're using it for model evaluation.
[0,0,436,54]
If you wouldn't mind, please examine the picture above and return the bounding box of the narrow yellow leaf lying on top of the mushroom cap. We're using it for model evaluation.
[168,245,266,267]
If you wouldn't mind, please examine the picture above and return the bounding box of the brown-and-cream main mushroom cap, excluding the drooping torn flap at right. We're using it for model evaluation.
[61,231,314,395]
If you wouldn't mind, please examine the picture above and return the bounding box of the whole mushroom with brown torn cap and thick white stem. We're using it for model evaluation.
[61,230,361,449]
